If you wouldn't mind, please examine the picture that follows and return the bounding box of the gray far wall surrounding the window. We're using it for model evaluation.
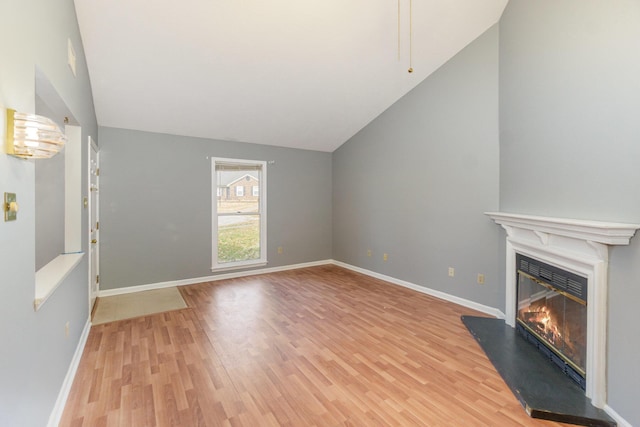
[100,127,332,290]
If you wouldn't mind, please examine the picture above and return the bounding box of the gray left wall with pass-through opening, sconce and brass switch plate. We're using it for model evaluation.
[0,0,97,427]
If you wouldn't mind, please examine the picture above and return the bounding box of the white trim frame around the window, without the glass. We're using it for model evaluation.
[211,157,267,272]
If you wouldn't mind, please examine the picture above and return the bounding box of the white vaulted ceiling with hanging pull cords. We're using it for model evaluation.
[75,0,508,152]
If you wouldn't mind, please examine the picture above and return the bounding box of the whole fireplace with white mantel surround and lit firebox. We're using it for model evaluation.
[487,212,640,408]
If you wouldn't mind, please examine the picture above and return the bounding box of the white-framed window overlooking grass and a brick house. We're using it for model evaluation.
[211,158,267,271]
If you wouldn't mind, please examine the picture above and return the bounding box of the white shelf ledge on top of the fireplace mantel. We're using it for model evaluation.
[485,212,640,245]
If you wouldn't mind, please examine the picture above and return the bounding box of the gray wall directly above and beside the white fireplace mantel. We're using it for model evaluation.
[500,0,640,425]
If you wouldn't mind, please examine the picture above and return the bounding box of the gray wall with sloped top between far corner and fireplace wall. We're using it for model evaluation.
[333,26,504,307]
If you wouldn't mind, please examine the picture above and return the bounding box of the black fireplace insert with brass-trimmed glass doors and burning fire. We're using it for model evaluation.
[516,254,587,390]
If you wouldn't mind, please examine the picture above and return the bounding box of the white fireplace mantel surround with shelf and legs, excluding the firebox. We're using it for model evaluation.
[485,212,640,408]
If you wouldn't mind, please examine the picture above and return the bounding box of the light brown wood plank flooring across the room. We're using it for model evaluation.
[60,266,564,427]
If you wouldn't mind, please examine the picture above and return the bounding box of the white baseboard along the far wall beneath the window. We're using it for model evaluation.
[98,259,333,297]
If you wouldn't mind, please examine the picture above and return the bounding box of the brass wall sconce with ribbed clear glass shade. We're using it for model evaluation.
[5,108,67,159]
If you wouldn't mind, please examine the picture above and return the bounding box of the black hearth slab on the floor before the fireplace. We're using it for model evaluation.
[462,316,616,427]
